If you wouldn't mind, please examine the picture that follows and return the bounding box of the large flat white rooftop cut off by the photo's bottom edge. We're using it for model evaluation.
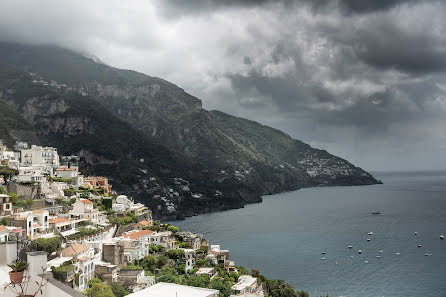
[127,283,219,297]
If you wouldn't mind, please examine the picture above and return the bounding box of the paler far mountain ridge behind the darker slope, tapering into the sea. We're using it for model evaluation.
[0,43,379,217]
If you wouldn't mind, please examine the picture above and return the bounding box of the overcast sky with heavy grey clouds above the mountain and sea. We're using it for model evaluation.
[0,0,446,170]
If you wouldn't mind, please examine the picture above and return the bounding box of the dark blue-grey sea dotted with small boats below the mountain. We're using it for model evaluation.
[166,174,446,297]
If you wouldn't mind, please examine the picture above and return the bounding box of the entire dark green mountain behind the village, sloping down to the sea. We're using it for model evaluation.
[0,43,378,218]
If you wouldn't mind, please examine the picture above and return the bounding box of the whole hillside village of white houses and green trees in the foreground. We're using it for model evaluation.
[0,141,305,297]
